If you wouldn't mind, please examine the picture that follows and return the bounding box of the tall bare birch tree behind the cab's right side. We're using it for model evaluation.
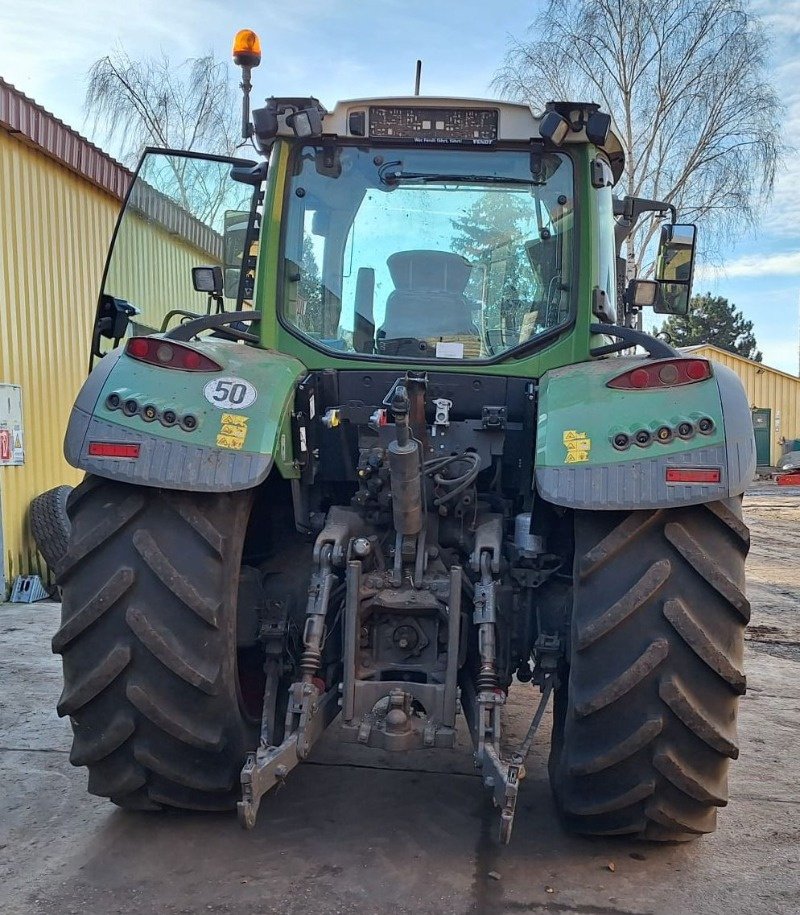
[495,0,782,269]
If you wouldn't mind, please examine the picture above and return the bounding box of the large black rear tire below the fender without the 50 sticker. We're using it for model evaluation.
[550,498,750,841]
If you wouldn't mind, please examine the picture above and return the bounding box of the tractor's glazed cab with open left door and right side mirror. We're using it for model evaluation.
[93,78,694,376]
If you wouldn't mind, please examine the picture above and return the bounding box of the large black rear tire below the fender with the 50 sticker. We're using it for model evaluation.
[53,477,258,810]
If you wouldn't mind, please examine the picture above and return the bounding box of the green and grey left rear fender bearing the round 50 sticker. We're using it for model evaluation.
[64,340,306,492]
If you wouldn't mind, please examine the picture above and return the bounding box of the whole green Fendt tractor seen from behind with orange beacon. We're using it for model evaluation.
[53,33,755,842]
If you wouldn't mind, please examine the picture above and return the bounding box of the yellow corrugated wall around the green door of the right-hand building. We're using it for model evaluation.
[692,346,800,466]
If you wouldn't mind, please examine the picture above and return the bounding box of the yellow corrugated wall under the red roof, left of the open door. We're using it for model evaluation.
[0,129,119,579]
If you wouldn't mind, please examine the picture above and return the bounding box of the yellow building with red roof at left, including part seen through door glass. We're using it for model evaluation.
[0,78,230,599]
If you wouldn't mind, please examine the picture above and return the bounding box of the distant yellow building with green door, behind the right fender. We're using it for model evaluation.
[683,344,800,467]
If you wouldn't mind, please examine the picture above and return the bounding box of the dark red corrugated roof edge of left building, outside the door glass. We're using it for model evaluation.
[0,76,133,200]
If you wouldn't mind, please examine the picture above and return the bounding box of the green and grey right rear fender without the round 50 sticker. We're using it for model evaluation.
[535,356,755,510]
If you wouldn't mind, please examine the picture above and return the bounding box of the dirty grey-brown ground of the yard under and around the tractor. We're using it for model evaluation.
[0,483,800,915]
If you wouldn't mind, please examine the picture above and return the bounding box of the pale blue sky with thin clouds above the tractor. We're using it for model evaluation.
[0,0,800,374]
